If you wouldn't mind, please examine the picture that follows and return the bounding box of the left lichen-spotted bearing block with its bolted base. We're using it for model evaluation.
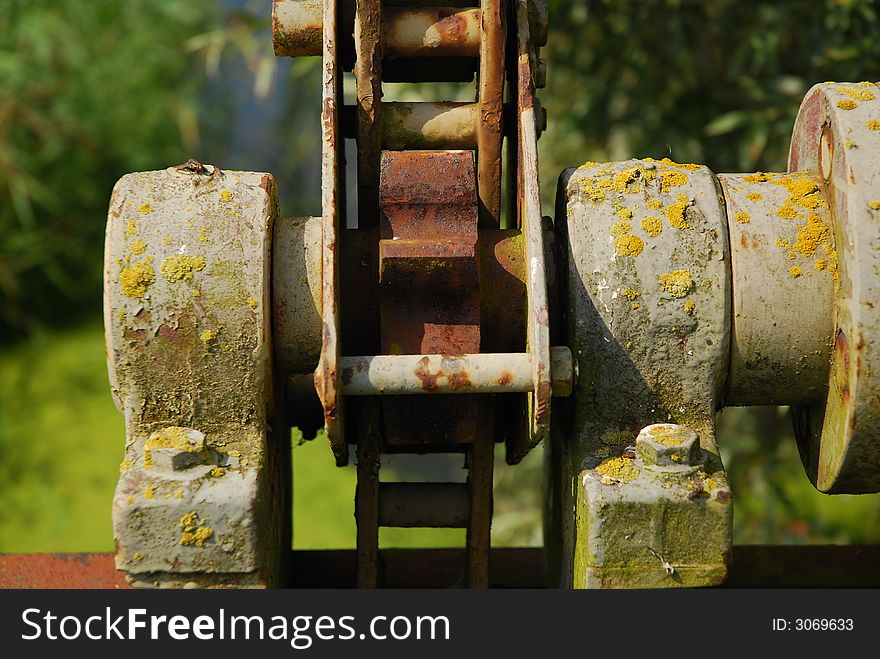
[104,161,290,587]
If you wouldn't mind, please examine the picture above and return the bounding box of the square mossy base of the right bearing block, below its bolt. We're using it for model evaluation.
[572,426,733,588]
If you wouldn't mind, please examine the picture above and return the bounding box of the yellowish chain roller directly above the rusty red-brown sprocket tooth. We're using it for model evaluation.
[382,102,480,151]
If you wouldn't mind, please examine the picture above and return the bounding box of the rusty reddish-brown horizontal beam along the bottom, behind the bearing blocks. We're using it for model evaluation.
[6,545,880,589]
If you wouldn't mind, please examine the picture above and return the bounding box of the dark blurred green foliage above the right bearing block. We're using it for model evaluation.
[540,0,880,199]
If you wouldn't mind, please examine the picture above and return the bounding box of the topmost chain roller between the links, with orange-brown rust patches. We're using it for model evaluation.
[382,7,480,58]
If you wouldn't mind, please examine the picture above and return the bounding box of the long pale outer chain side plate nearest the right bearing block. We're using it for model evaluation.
[506,0,552,464]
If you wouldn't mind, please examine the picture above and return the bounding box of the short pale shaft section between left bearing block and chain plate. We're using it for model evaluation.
[272,217,321,373]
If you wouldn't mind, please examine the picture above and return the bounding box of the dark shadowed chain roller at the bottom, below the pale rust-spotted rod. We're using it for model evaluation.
[379,483,470,529]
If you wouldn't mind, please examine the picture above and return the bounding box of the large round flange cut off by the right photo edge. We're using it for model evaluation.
[789,82,880,493]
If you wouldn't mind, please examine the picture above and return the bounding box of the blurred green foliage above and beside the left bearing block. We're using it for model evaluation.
[0,0,220,339]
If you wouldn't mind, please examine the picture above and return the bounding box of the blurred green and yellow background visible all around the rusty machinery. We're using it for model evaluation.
[0,0,880,552]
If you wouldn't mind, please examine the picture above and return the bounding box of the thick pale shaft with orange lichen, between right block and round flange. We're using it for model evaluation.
[718,172,838,405]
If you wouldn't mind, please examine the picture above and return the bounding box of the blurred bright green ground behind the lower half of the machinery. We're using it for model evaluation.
[0,324,880,552]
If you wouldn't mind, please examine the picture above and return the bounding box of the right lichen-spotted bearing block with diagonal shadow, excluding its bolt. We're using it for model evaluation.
[548,160,731,587]
